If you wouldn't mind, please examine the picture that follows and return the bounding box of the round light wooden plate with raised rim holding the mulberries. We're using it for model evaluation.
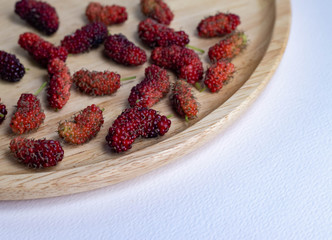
[0,0,290,200]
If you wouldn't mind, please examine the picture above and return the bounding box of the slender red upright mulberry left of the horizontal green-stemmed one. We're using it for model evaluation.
[47,58,73,110]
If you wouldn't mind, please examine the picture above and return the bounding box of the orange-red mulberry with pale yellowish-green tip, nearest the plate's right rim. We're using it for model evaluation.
[209,32,247,62]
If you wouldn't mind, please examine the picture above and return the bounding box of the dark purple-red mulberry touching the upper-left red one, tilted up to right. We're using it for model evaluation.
[61,22,107,54]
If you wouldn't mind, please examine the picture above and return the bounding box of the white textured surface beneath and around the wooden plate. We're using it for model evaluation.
[0,0,332,240]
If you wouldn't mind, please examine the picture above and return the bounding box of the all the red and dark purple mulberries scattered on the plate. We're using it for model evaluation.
[0,0,247,168]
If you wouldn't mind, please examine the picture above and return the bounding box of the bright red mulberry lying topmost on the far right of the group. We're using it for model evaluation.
[197,13,241,38]
